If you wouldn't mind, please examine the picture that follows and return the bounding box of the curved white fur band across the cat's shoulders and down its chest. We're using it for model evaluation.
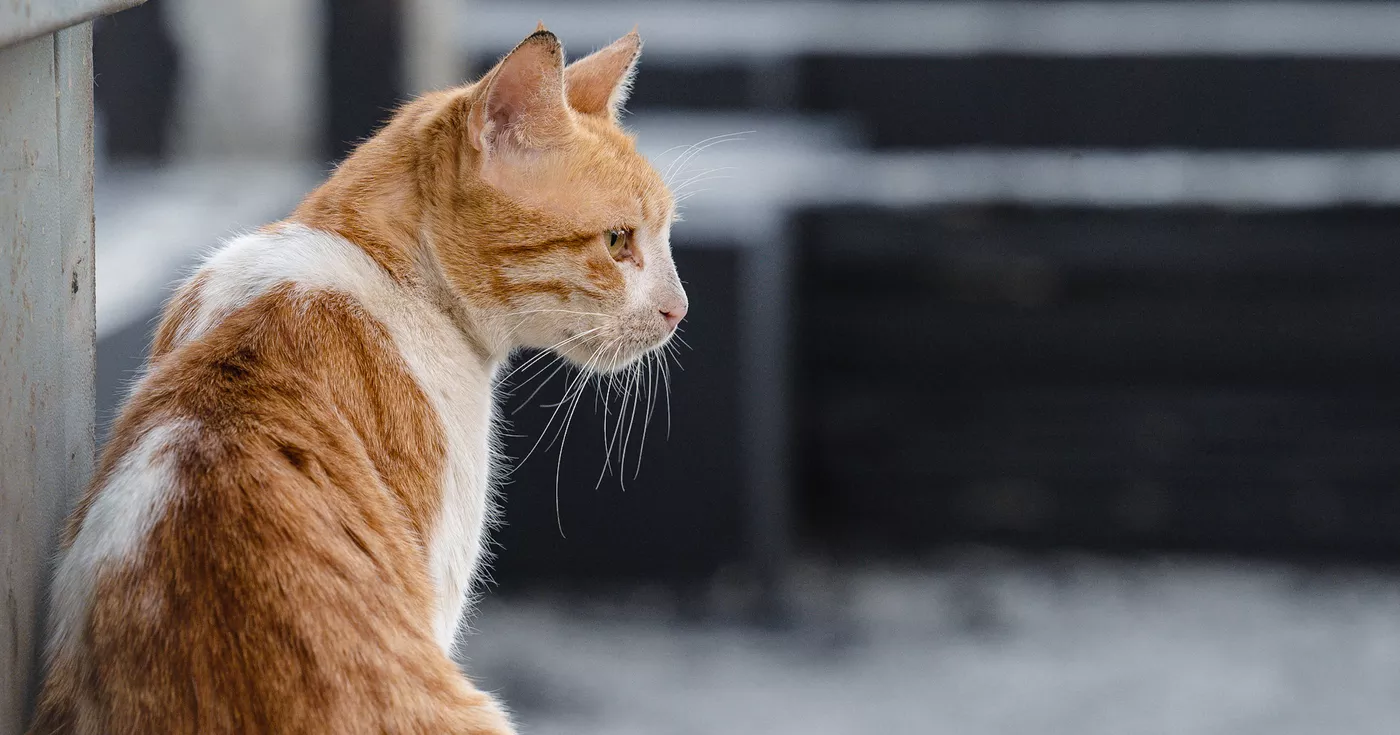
[168,225,496,652]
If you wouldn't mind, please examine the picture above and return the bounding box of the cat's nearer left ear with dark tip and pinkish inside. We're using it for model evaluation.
[466,31,570,154]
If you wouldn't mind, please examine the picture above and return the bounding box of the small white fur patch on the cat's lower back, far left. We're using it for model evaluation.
[49,421,195,657]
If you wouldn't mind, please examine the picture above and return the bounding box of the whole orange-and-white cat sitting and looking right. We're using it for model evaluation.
[31,27,687,735]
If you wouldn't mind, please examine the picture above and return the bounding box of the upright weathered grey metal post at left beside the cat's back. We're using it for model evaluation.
[0,22,95,735]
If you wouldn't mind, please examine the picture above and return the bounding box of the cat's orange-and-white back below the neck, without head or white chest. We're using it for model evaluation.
[34,225,492,732]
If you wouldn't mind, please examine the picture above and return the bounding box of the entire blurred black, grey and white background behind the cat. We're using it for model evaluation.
[95,0,1400,735]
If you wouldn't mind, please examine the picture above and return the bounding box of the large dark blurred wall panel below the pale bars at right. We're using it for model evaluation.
[798,207,1400,556]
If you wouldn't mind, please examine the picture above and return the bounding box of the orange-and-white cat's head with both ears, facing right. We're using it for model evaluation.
[433,29,687,372]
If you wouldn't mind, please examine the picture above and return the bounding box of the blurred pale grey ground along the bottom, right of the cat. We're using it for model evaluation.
[463,556,1400,735]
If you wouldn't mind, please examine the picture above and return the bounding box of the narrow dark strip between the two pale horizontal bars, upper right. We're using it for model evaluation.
[799,55,1400,150]
